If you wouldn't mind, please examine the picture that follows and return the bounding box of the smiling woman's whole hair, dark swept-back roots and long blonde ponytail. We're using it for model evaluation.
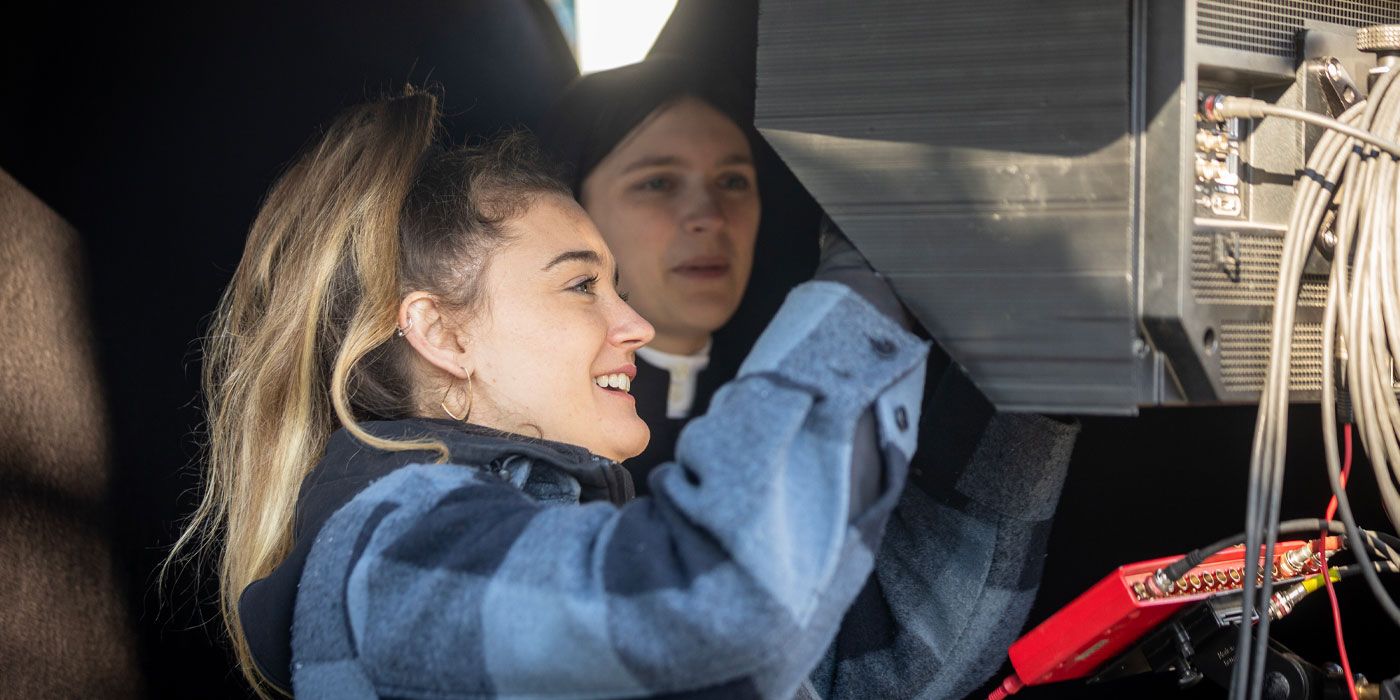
[161,84,570,697]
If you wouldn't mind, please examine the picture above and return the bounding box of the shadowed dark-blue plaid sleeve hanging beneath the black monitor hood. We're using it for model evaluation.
[811,367,1079,700]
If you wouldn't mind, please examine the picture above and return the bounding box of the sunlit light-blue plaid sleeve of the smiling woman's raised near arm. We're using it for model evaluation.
[293,283,927,699]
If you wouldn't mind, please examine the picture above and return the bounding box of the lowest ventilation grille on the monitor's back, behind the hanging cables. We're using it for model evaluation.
[1219,322,1322,393]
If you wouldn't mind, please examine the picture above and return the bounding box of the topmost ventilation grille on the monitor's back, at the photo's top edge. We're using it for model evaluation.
[1196,0,1400,59]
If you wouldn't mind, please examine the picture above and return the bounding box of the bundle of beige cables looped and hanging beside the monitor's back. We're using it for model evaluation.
[1203,56,1400,700]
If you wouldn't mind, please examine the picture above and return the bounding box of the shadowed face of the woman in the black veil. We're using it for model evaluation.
[580,98,759,354]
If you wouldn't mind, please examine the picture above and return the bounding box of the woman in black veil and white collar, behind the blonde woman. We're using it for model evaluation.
[542,57,772,494]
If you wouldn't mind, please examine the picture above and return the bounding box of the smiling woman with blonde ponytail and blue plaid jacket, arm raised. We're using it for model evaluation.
[172,87,925,699]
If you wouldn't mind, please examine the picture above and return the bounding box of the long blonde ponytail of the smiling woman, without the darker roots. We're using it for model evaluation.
[167,92,445,696]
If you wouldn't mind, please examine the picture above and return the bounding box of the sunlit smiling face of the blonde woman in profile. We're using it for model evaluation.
[466,196,654,461]
